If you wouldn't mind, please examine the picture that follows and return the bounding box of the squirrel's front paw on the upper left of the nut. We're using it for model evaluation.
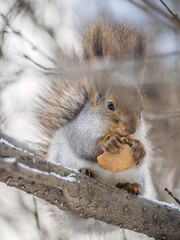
[100,134,123,153]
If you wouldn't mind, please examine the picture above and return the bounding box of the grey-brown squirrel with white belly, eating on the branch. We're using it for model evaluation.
[36,21,155,239]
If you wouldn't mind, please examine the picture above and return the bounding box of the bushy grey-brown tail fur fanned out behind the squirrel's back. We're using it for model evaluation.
[37,76,91,150]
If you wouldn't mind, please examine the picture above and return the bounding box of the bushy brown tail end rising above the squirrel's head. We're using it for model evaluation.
[83,21,145,60]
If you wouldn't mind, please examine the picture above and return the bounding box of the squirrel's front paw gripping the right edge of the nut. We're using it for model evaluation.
[129,140,146,164]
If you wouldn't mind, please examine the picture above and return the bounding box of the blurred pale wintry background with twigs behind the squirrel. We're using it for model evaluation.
[0,0,180,240]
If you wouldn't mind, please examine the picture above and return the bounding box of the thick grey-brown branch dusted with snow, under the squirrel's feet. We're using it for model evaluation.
[0,133,180,240]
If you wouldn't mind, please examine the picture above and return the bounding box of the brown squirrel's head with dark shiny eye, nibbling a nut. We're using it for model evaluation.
[91,74,143,136]
